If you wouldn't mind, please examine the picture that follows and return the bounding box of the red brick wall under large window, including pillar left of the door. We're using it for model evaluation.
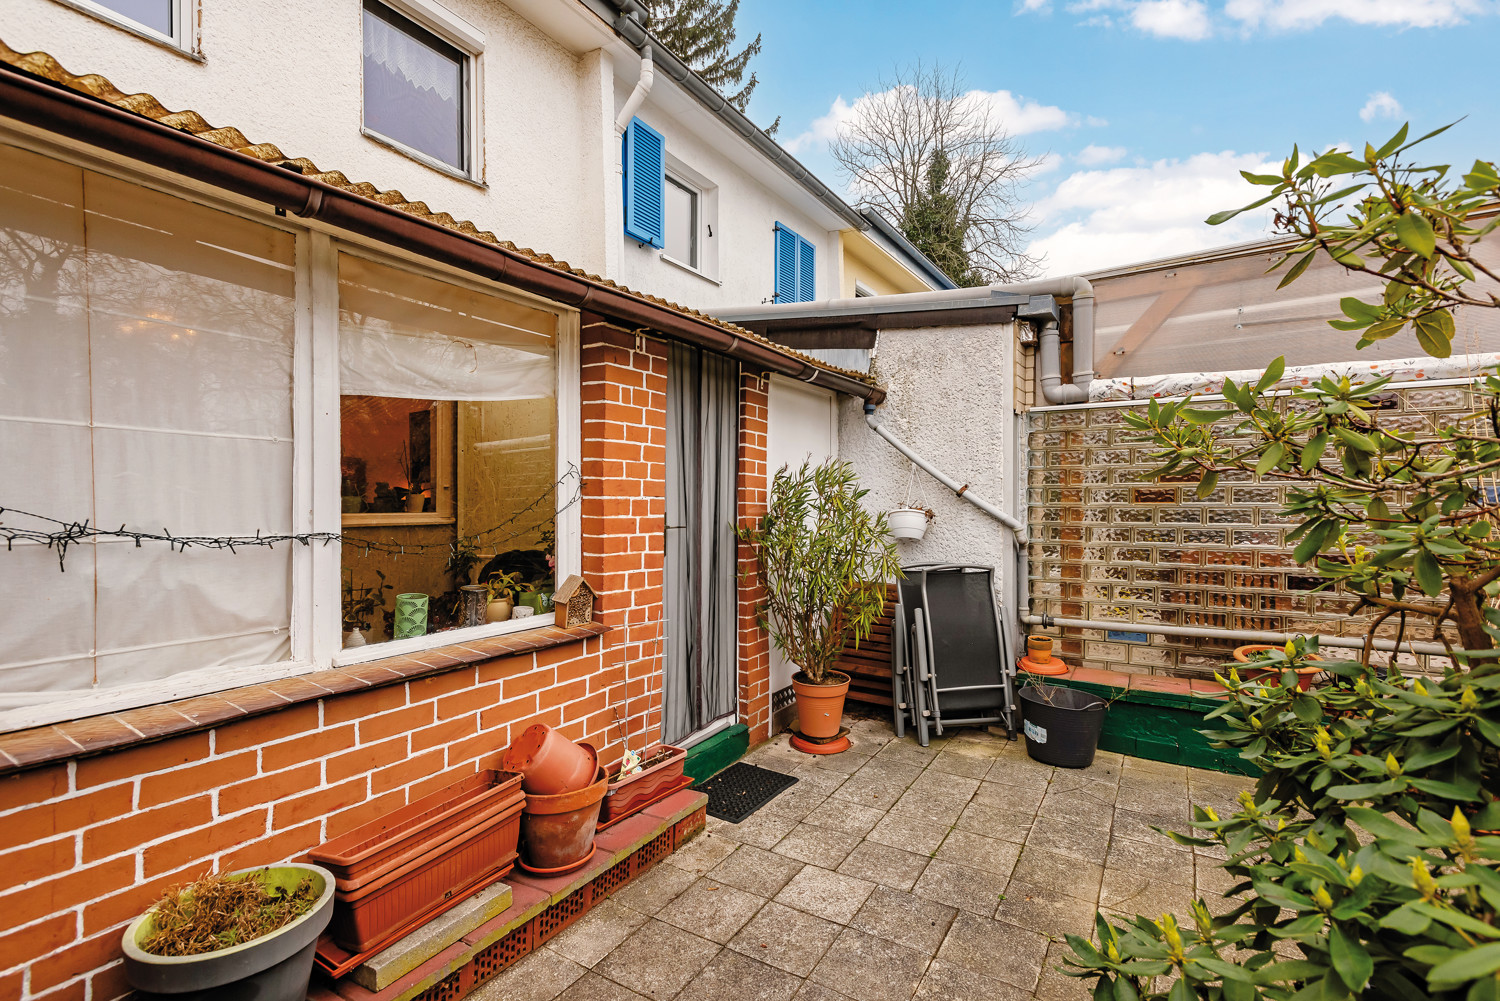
[0,320,675,1001]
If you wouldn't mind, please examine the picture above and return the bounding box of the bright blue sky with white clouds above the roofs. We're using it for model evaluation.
[738,0,1500,273]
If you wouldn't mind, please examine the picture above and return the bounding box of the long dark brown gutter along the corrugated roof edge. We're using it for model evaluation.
[0,66,885,402]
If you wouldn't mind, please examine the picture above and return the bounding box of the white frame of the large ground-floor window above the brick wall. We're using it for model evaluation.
[0,125,584,732]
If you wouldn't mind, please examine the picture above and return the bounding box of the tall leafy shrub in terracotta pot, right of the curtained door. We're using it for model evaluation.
[735,459,902,740]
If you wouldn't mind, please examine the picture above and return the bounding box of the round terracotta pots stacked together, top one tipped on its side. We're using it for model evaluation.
[503,723,609,875]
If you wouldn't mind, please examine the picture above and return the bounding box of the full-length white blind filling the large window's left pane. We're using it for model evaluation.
[0,146,294,707]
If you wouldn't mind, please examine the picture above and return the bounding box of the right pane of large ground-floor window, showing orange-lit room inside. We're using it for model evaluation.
[339,255,561,645]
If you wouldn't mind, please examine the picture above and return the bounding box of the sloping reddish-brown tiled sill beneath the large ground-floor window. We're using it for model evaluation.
[0,623,609,774]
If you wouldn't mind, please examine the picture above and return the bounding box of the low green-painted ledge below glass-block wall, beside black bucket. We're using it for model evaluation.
[1046,678,1256,774]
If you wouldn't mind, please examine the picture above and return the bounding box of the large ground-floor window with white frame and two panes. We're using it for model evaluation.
[0,143,581,731]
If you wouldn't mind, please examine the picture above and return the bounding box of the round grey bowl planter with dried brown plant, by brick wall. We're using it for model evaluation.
[120,864,335,1001]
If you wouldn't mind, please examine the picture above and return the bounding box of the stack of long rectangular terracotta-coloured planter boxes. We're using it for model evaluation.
[308,771,525,953]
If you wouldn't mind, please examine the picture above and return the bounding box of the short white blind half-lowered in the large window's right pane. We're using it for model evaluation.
[339,255,557,401]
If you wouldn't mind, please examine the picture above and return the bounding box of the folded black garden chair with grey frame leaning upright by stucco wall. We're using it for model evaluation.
[905,563,1020,744]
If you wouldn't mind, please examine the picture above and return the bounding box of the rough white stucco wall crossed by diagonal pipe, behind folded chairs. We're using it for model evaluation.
[839,324,1025,645]
